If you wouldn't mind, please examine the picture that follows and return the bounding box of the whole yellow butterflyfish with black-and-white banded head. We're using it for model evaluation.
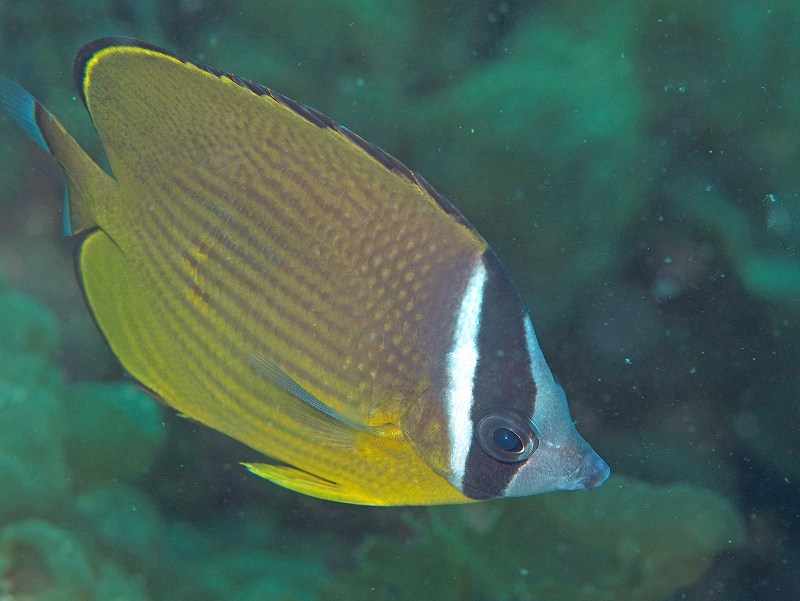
[0,38,609,505]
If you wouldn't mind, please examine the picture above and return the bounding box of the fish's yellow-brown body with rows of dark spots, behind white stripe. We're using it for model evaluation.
[26,39,494,505]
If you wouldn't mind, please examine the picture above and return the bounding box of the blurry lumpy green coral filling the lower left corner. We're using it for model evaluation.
[0,274,326,601]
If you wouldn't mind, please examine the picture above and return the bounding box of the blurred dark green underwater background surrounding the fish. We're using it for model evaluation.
[0,0,800,601]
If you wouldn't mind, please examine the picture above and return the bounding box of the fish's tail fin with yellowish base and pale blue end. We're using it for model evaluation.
[0,76,116,236]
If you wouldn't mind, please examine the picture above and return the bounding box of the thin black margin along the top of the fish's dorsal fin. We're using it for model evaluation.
[72,36,482,232]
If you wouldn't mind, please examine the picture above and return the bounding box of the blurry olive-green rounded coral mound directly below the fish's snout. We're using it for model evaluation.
[324,476,744,601]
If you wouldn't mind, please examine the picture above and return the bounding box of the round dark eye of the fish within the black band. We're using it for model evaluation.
[477,409,539,463]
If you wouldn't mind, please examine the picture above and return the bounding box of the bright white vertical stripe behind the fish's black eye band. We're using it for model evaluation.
[447,261,486,488]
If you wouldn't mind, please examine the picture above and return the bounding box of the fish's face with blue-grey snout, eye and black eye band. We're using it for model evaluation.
[451,292,610,499]
